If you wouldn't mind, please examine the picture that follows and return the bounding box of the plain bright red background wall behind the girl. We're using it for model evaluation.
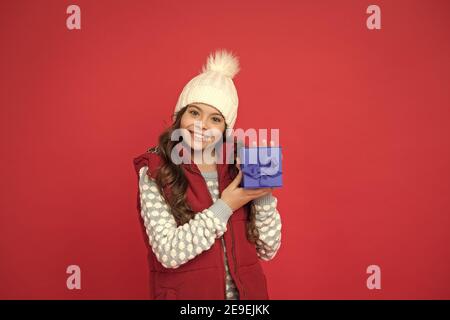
[0,0,450,299]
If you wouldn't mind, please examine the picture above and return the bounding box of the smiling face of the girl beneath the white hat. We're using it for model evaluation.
[180,103,225,150]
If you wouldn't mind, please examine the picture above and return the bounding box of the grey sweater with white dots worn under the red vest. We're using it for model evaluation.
[139,166,281,300]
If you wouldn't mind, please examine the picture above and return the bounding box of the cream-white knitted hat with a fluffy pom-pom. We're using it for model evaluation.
[175,50,239,128]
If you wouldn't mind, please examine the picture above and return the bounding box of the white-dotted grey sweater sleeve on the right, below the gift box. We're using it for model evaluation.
[253,194,281,261]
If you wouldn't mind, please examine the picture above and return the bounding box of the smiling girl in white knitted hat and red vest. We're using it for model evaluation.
[134,50,281,300]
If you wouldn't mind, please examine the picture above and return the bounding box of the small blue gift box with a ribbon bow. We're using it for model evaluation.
[239,147,283,189]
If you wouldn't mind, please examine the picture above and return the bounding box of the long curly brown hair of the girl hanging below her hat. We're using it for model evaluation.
[152,106,259,243]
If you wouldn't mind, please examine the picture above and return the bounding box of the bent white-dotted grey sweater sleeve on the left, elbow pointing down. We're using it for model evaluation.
[139,166,233,269]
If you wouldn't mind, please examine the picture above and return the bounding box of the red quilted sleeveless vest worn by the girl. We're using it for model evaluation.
[133,143,269,300]
